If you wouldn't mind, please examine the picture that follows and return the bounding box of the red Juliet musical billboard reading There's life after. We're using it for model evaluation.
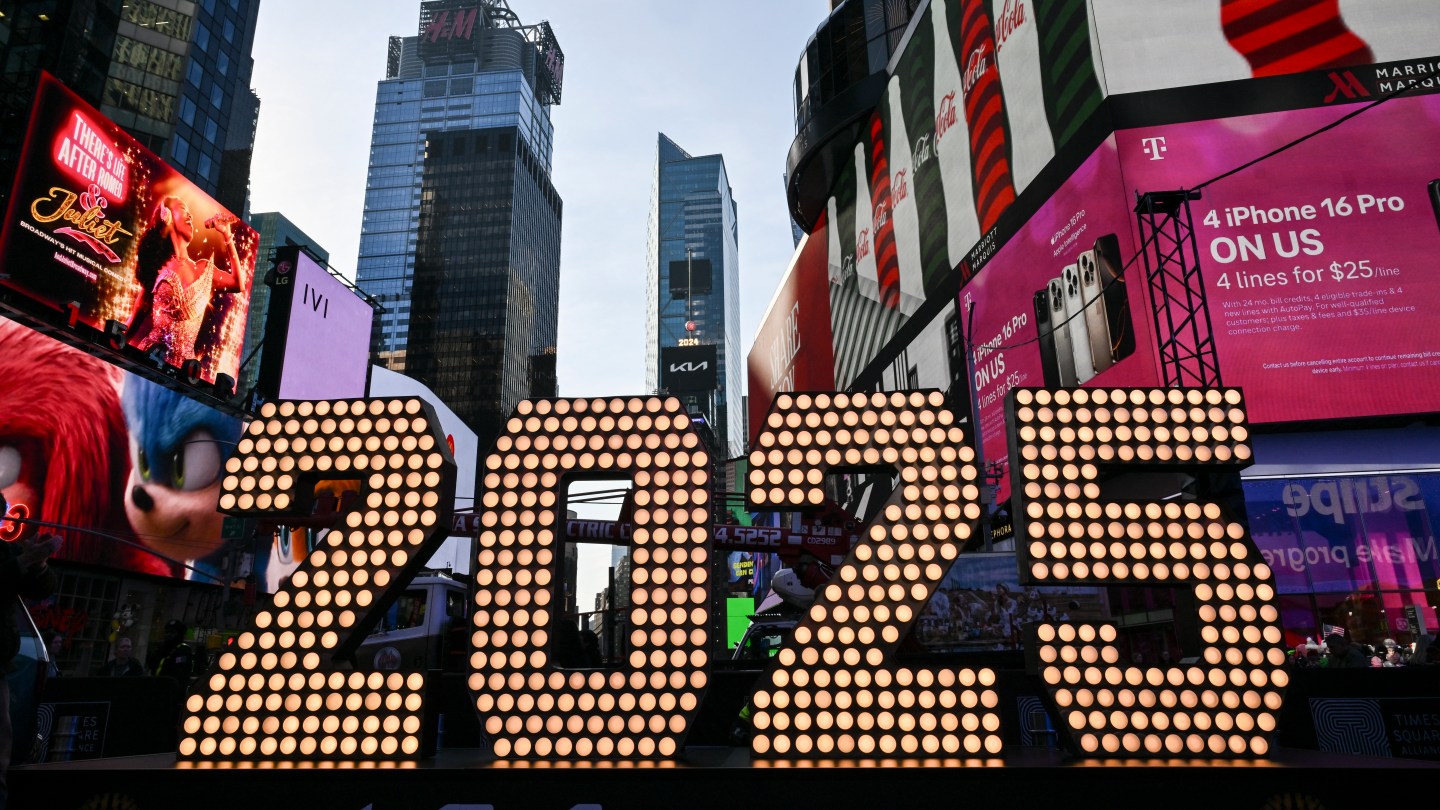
[0,74,258,383]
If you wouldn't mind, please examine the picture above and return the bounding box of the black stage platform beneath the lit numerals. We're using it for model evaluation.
[10,748,1440,810]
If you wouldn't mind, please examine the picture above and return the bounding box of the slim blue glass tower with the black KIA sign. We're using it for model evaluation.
[645,134,744,457]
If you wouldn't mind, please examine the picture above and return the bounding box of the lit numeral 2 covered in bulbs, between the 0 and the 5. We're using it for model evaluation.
[747,391,1001,760]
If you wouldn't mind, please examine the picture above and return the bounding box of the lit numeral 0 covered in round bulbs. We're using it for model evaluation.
[469,396,711,760]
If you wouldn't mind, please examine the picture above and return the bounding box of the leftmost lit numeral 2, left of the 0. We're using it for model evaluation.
[179,399,455,761]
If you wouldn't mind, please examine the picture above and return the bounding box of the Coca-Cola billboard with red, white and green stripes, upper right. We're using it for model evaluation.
[760,0,1440,397]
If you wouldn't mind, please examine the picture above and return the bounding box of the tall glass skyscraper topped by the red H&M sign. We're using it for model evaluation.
[357,0,564,445]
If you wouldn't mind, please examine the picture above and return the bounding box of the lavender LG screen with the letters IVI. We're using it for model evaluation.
[259,246,374,399]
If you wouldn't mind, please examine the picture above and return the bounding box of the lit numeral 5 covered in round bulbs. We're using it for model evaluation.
[1008,389,1289,758]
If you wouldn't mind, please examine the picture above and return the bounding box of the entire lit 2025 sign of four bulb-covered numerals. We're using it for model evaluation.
[180,389,1287,760]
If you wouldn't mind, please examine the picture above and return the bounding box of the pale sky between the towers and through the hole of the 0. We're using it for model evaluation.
[251,0,829,610]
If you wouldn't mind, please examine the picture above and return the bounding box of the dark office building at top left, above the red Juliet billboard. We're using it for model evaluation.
[0,0,261,215]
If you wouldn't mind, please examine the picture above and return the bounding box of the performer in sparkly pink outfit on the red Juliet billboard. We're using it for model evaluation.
[127,196,245,368]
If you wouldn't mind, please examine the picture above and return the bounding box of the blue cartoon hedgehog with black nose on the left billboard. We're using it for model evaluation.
[121,375,242,579]
